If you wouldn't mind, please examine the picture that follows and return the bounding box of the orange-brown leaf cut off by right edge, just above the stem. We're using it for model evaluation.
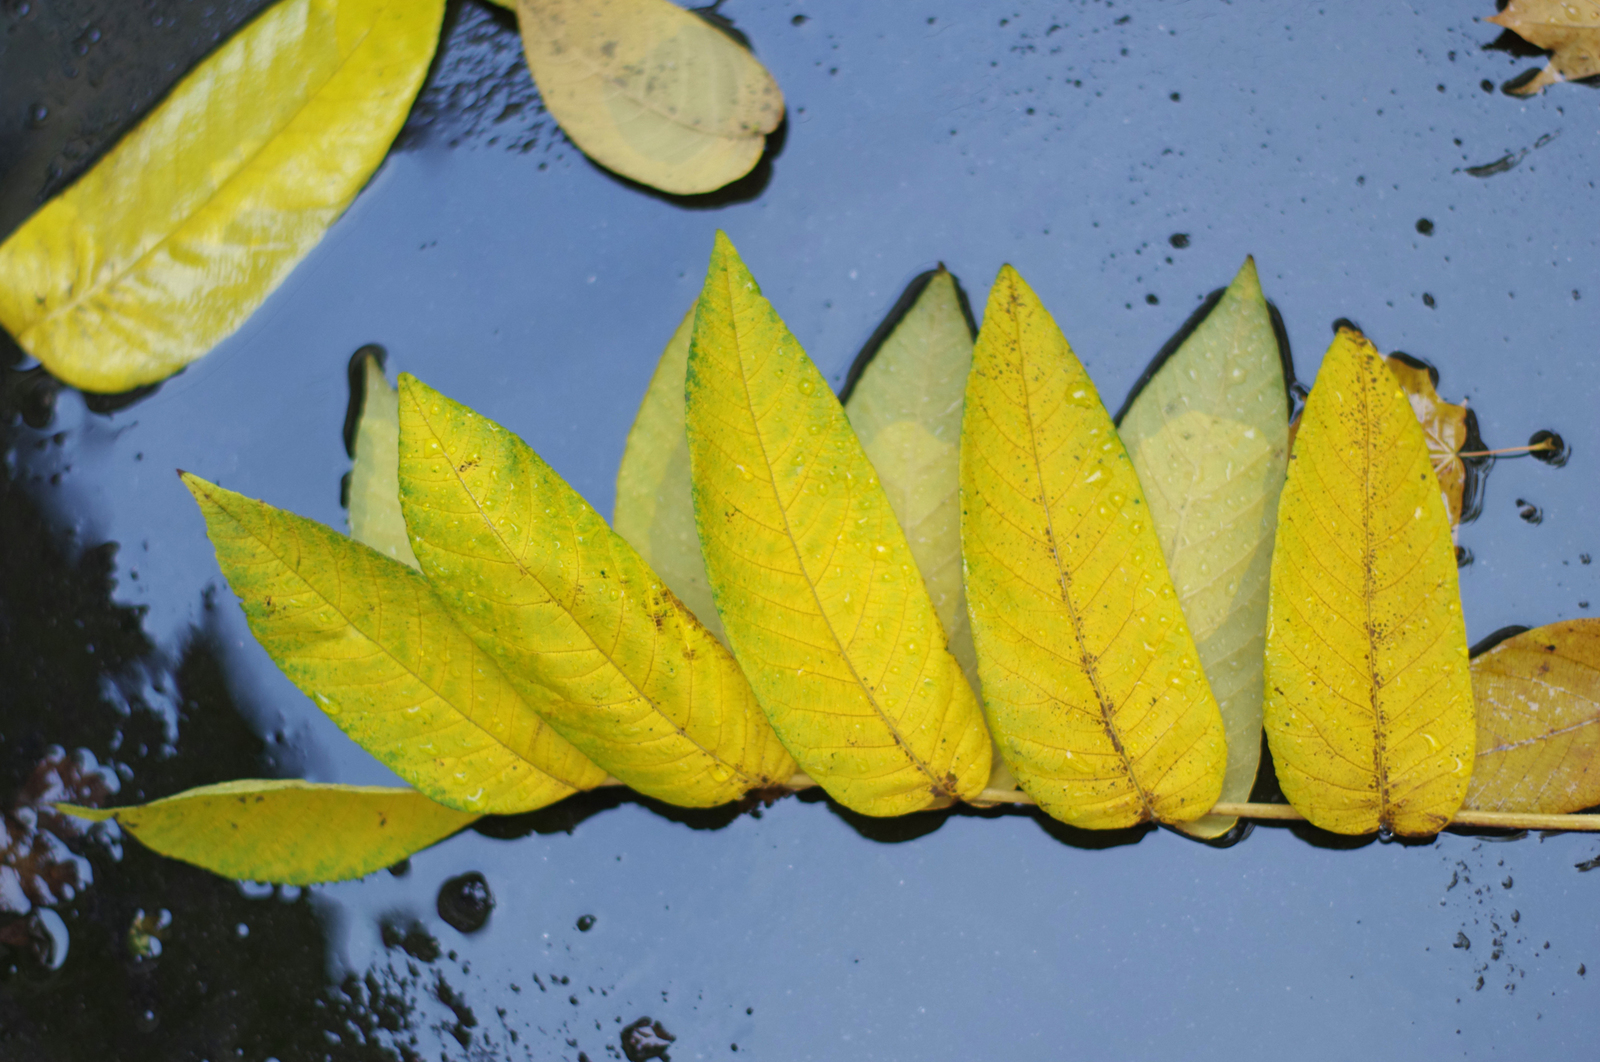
[1462,619,1600,814]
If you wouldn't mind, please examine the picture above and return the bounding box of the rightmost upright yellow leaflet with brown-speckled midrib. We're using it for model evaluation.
[1266,329,1474,836]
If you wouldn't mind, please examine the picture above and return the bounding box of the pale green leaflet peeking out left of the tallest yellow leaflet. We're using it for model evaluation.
[611,307,726,640]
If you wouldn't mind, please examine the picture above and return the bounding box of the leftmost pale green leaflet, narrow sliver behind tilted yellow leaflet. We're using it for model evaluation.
[350,355,421,571]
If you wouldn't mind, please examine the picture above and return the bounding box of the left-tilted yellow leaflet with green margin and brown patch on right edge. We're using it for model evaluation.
[400,376,794,808]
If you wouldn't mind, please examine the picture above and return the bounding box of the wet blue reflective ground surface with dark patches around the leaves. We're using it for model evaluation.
[0,0,1600,1062]
